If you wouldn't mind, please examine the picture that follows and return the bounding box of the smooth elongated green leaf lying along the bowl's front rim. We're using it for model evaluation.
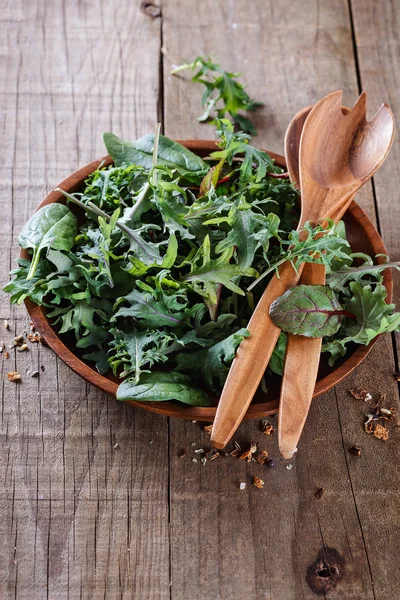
[117,371,210,406]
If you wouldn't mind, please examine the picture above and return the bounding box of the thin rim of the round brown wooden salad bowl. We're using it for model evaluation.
[20,139,393,421]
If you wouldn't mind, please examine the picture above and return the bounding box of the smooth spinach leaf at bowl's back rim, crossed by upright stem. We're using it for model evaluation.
[103,133,208,176]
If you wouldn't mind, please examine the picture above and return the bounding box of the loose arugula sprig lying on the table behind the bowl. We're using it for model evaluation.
[171,56,263,135]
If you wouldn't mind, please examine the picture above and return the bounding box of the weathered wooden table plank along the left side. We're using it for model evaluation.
[0,0,169,600]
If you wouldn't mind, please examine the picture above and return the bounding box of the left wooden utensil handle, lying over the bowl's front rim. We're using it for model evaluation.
[211,263,304,448]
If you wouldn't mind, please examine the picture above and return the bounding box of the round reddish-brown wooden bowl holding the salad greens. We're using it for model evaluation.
[21,140,393,421]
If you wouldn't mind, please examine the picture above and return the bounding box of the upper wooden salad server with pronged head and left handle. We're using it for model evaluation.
[211,91,394,448]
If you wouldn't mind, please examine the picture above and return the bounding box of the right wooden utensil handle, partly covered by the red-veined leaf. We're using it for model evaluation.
[278,263,325,458]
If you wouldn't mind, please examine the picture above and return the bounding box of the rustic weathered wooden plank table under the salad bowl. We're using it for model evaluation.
[0,0,400,600]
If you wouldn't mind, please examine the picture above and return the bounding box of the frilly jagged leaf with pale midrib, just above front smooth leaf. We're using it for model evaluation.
[109,329,176,383]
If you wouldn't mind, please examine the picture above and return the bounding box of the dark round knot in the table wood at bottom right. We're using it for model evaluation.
[306,548,345,596]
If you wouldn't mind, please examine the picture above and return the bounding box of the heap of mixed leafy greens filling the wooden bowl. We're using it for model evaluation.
[4,119,400,405]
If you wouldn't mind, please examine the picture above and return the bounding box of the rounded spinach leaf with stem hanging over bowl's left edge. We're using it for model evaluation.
[18,203,77,280]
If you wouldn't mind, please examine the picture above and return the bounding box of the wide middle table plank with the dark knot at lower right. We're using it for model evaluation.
[163,0,399,600]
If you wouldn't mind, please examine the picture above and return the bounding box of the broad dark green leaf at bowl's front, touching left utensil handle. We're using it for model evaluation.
[176,329,250,391]
